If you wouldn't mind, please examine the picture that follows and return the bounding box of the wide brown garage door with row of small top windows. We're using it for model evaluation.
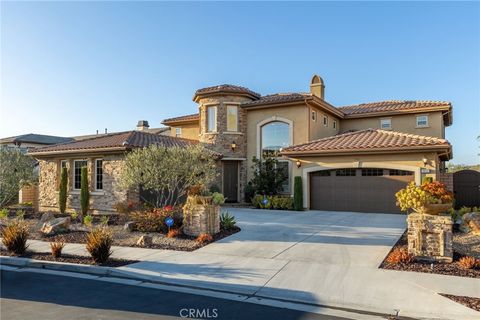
[310,168,414,213]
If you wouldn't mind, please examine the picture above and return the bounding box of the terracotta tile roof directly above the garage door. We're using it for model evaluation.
[281,129,451,155]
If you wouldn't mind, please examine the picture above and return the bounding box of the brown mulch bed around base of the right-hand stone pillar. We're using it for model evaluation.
[379,232,480,278]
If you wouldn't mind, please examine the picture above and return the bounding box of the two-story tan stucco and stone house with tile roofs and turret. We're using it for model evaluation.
[31,75,452,212]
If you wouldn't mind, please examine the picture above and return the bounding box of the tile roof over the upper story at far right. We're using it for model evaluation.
[338,100,451,116]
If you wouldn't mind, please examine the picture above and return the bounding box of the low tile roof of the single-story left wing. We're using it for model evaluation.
[29,131,220,156]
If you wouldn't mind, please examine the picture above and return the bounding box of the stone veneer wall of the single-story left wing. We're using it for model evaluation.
[39,155,139,214]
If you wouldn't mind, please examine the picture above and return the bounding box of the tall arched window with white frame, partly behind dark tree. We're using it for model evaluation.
[260,121,290,192]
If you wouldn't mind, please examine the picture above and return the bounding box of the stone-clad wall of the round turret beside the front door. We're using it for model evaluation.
[199,95,251,202]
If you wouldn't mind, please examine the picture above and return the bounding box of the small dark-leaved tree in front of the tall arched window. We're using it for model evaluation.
[251,156,288,195]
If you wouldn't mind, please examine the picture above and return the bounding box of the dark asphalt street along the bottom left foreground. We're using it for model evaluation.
[0,270,352,320]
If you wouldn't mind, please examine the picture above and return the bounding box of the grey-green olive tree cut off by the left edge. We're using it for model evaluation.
[0,147,37,208]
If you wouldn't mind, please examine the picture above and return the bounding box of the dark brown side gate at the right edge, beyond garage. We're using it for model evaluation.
[453,170,480,209]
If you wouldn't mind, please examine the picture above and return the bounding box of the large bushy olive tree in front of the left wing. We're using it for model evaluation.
[120,145,216,208]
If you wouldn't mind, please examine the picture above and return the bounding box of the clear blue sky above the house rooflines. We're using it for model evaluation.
[0,1,480,163]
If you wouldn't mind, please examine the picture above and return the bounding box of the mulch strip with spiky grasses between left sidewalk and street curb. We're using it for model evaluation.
[0,250,138,267]
